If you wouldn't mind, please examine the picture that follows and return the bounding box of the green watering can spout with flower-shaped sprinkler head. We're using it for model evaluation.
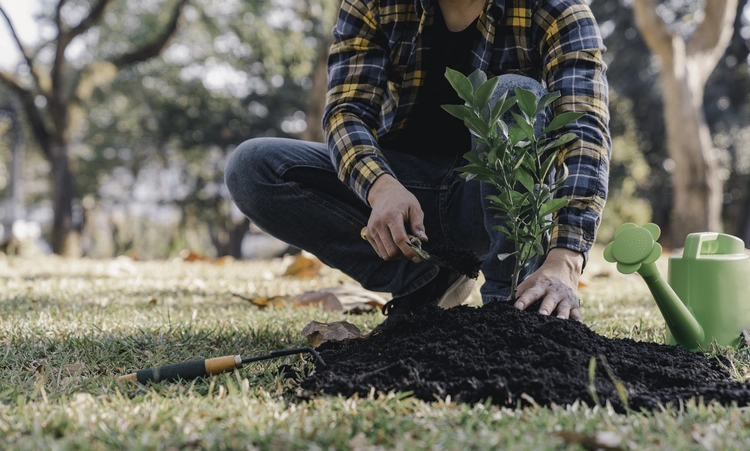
[604,223,706,349]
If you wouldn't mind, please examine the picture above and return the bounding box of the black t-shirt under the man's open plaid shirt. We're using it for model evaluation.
[381,4,476,155]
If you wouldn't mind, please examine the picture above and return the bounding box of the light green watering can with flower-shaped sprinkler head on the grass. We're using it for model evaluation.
[604,223,750,351]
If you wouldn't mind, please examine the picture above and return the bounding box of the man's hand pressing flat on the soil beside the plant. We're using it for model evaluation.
[515,248,583,322]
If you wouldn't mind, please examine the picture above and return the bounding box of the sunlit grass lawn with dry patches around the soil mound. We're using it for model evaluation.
[0,249,750,450]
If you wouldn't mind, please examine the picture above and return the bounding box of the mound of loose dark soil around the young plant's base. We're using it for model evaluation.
[302,302,750,411]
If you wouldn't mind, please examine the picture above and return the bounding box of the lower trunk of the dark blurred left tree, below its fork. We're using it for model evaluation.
[51,144,80,256]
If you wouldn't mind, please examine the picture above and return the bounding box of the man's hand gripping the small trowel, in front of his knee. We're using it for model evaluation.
[367,174,427,262]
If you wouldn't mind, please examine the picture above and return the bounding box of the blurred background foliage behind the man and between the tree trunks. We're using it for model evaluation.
[0,0,750,258]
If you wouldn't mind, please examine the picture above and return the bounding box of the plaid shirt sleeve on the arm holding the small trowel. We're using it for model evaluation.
[323,0,395,203]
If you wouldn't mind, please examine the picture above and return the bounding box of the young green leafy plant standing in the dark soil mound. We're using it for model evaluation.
[443,68,583,299]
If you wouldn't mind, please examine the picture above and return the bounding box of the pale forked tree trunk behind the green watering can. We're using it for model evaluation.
[633,0,737,247]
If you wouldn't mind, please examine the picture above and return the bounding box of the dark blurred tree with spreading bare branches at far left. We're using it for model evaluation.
[0,0,188,254]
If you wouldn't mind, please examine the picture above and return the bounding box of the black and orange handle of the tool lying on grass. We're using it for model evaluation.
[117,355,242,385]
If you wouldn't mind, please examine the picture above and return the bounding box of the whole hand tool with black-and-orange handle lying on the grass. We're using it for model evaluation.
[117,346,325,384]
